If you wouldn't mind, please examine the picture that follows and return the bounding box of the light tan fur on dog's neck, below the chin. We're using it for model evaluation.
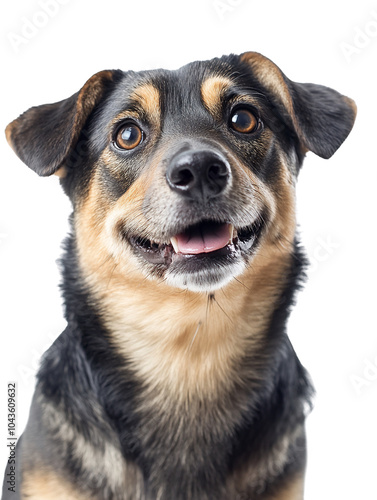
[61,222,300,398]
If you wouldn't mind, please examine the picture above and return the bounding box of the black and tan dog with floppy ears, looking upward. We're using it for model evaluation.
[3,52,356,500]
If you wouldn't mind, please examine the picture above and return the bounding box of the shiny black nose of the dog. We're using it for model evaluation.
[166,151,231,201]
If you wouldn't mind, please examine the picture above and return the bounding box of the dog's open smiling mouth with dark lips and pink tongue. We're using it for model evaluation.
[128,218,263,272]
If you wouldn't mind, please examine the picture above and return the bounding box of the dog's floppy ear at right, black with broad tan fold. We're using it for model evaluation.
[240,52,356,159]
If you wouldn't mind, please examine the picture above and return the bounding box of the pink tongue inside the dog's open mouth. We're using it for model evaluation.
[176,222,230,254]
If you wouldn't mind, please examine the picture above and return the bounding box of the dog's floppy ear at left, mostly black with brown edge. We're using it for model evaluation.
[5,71,116,176]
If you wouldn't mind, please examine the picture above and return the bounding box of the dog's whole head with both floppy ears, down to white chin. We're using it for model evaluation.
[7,52,356,292]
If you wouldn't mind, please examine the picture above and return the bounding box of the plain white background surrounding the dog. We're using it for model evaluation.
[0,0,377,500]
